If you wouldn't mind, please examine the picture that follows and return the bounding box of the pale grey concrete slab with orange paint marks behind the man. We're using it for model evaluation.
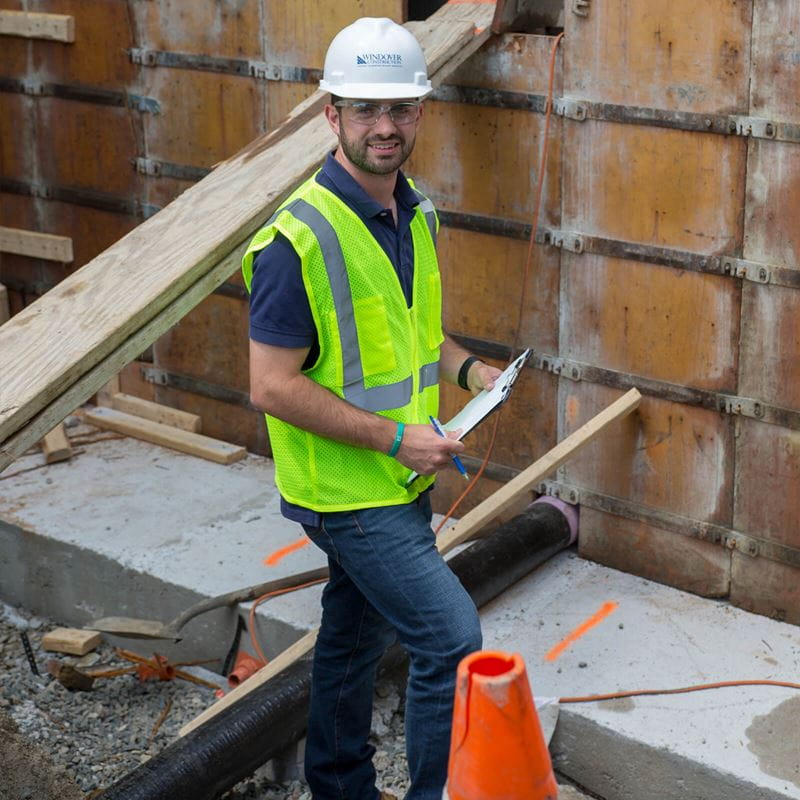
[0,432,800,800]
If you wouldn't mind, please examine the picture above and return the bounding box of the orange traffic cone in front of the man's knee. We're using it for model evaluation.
[444,650,558,800]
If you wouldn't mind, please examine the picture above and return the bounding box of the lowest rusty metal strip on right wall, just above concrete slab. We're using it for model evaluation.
[537,481,800,567]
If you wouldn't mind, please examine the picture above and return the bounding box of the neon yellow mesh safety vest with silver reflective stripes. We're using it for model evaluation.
[242,176,444,511]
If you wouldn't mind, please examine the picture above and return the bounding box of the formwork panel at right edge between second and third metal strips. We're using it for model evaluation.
[739,284,800,410]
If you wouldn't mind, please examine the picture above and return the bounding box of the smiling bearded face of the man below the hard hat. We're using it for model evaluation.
[336,99,422,175]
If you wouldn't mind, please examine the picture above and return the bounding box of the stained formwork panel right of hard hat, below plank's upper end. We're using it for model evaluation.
[447,33,564,97]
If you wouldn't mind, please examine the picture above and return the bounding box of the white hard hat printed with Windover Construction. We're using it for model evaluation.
[319,17,433,100]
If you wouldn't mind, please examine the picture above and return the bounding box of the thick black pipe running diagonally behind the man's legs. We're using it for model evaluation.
[97,498,577,800]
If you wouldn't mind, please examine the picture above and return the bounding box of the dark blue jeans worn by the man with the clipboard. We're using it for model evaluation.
[305,493,481,800]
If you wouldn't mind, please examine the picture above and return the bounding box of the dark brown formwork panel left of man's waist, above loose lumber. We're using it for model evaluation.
[153,386,272,456]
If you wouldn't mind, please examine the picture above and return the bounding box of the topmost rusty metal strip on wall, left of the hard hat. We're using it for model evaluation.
[128,47,322,83]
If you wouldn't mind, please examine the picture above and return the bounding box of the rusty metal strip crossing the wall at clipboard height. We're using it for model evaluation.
[449,331,800,430]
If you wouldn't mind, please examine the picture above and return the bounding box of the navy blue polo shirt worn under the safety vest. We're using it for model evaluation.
[250,153,419,527]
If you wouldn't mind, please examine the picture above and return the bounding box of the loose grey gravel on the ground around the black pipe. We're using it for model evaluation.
[0,603,408,800]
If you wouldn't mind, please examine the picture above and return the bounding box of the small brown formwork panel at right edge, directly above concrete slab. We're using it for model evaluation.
[730,553,800,625]
